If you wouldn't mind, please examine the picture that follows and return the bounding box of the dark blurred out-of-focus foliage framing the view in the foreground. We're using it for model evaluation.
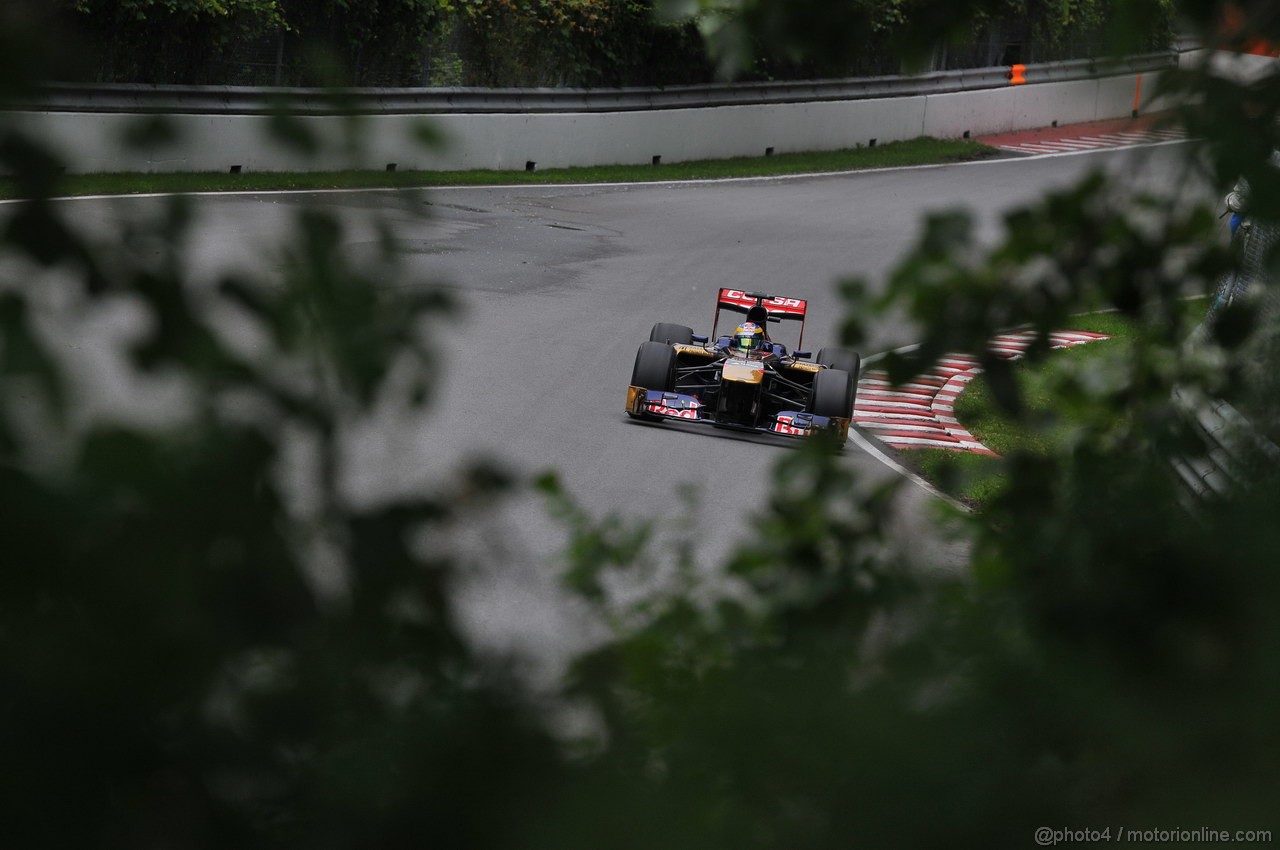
[0,4,1280,849]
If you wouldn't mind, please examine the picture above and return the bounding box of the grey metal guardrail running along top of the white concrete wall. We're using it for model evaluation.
[6,51,1178,115]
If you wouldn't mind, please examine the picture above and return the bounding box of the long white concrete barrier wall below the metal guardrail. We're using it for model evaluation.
[10,73,1160,173]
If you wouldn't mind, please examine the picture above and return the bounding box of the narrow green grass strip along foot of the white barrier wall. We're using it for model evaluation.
[0,137,998,198]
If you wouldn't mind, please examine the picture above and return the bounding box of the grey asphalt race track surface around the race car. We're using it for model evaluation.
[15,145,1203,666]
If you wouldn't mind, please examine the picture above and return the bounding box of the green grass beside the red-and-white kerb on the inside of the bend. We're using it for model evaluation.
[900,298,1208,511]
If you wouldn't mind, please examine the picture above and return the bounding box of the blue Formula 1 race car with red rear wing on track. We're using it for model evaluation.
[627,289,861,443]
